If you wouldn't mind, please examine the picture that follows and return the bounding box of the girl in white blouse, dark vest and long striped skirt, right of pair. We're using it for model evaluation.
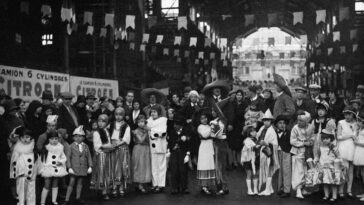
[109,107,131,197]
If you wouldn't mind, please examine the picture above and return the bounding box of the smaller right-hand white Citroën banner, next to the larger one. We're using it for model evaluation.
[70,76,119,99]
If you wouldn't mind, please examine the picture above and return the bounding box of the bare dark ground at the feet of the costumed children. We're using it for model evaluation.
[80,169,364,205]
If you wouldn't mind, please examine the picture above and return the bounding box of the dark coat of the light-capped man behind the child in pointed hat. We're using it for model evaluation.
[57,105,80,143]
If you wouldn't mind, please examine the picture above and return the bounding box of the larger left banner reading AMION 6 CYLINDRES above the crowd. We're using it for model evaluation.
[0,65,69,101]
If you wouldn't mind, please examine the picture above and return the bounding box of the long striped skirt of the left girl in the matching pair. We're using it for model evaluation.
[90,152,113,190]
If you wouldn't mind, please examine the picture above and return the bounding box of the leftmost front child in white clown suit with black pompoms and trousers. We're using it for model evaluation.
[10,127,37,205]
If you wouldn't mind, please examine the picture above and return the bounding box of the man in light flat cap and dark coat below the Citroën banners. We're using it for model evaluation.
[57,92,80,144]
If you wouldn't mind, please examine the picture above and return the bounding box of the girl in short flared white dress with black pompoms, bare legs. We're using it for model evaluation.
[39,131,68,205]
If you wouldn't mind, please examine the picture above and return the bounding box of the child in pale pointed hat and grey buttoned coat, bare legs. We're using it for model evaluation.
[64,126,92,205]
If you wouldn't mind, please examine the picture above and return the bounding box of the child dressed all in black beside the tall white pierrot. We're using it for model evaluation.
[168,115,190,194]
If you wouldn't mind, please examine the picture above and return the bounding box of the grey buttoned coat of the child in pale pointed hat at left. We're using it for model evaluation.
[67,142,92,176]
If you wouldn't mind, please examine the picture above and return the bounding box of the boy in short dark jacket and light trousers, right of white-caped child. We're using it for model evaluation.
[275,115,292,198]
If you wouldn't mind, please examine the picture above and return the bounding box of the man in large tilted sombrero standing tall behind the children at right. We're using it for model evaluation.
[273,74,296,129]
